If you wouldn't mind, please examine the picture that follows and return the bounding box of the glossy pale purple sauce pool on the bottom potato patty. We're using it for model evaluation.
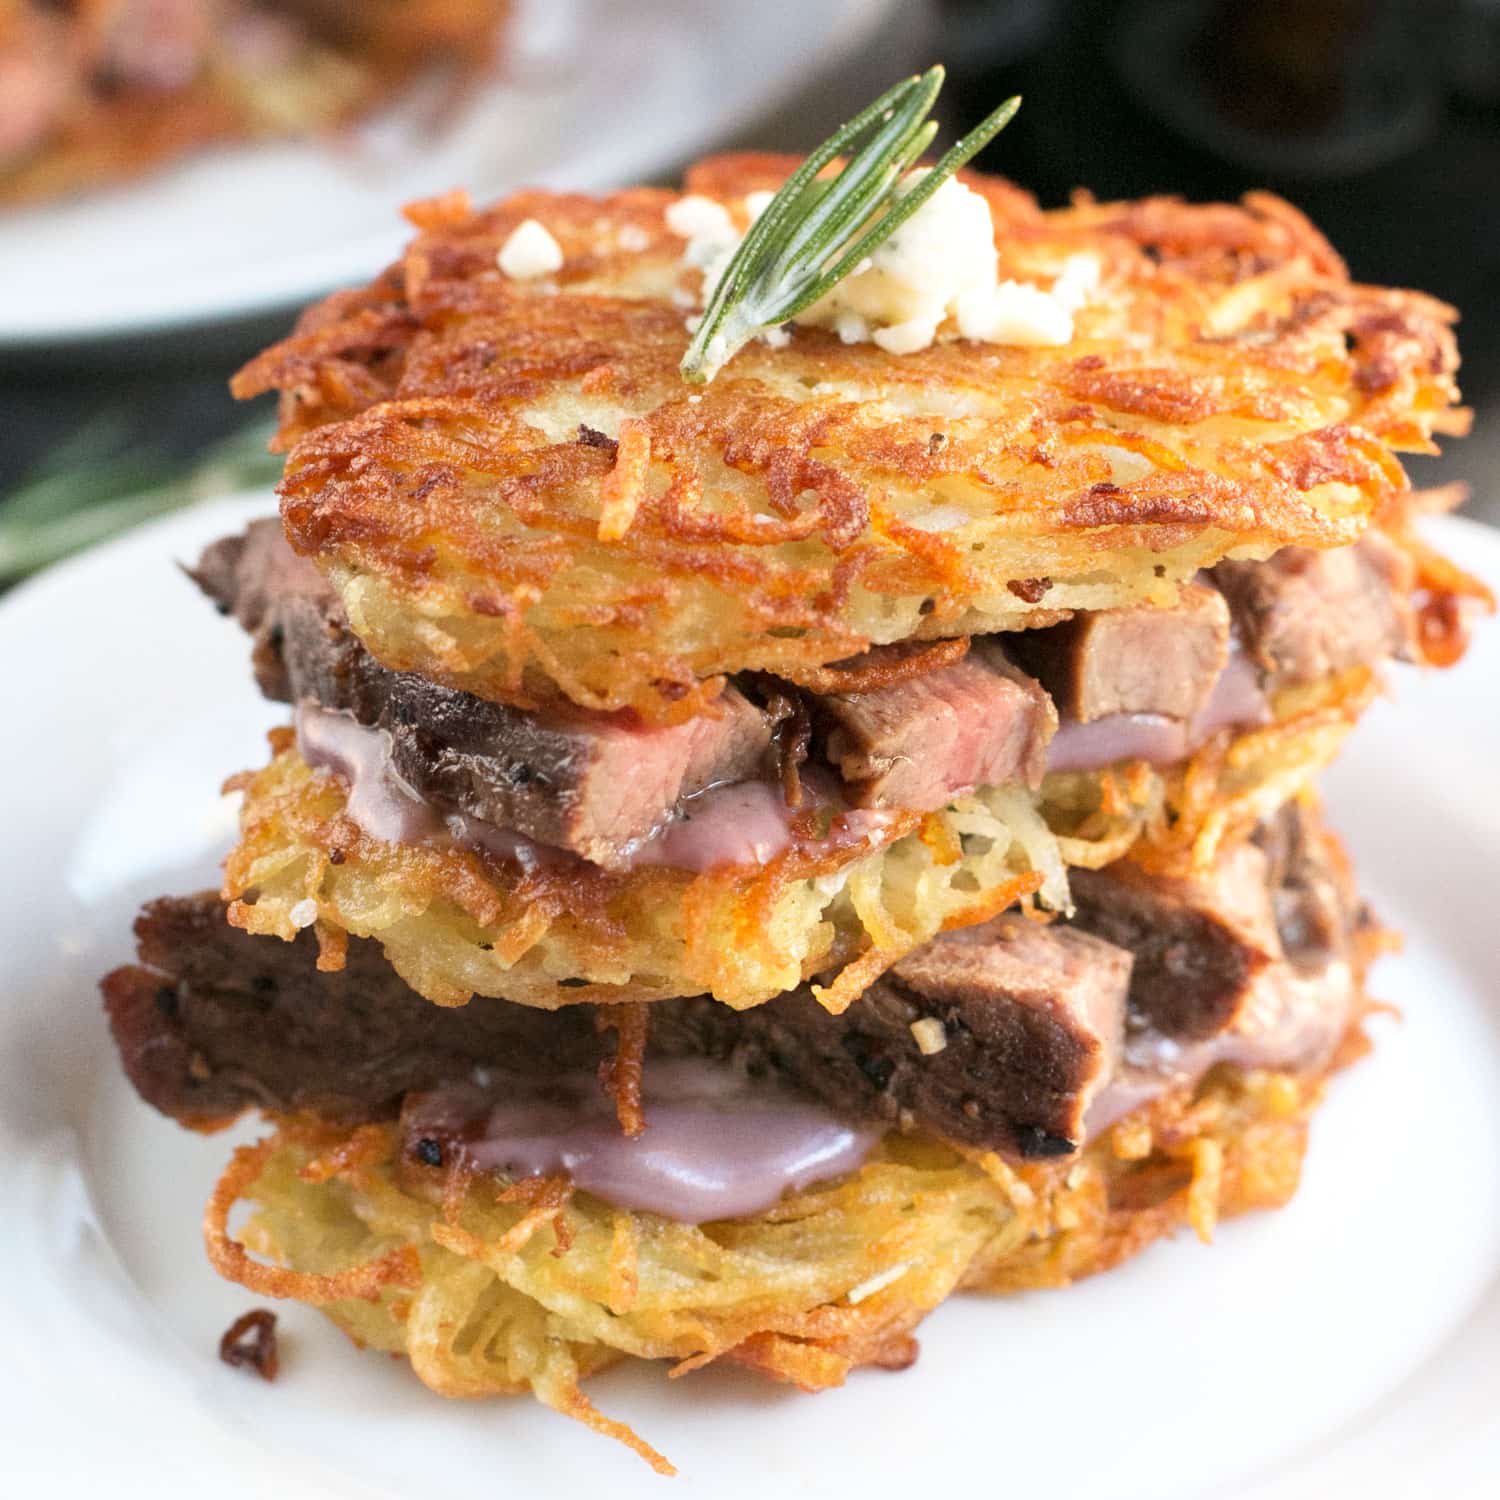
[402,1058,884,1224]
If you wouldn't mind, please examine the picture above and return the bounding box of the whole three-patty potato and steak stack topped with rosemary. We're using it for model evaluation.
[104,75,1485,1470]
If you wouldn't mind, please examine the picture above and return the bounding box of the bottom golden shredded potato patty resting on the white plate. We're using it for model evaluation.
[206,1049,1358,1472]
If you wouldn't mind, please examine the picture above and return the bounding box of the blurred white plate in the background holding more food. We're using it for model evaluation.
[0,0,894,348]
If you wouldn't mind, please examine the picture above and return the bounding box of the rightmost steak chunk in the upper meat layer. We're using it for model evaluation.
[1212,531,1416,686]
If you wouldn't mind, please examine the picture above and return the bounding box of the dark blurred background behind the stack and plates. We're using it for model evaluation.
[0,0,1500,522]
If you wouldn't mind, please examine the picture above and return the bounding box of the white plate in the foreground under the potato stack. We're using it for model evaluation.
[0,497,1500,1500]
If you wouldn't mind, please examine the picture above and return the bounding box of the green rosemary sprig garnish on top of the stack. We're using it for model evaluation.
[680,68,1022,384]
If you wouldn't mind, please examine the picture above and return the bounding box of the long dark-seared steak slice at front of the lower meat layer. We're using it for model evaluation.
[104,896,1130,1157]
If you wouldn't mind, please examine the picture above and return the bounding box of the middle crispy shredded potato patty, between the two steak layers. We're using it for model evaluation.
[224,671,1376,1011]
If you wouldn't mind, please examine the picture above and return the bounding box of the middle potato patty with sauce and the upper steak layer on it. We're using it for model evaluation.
[197,510,1418,1010]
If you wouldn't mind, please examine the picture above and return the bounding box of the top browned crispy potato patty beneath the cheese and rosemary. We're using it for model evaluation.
[236,156,1464,720]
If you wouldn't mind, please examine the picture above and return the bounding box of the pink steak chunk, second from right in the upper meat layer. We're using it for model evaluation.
[1005,584,1230,723]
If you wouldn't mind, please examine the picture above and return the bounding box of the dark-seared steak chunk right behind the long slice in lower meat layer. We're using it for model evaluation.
[1068,843,1283,1041]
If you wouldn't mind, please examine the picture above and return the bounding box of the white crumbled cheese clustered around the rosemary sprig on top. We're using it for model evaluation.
[666,170,1100,354]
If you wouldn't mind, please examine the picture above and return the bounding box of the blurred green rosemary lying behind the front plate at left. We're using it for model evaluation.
[0,413,282,584]
